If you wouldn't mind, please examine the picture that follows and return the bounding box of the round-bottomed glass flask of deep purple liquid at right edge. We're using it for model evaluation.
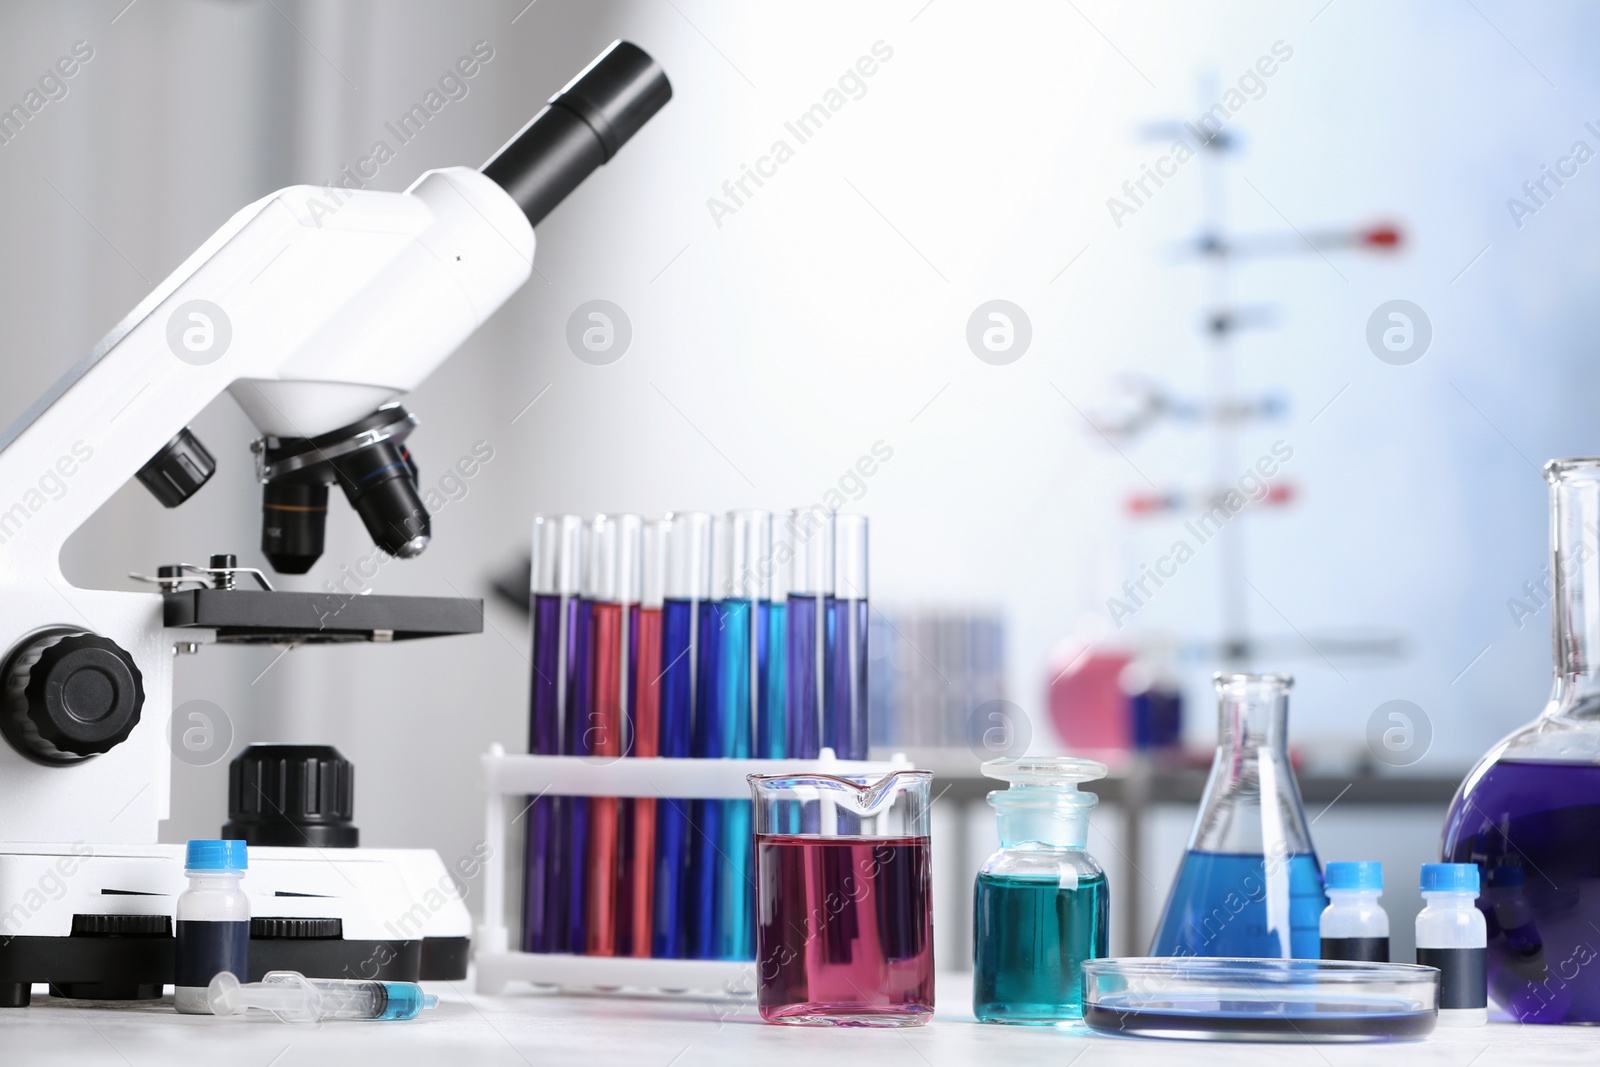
[1440,458,1600,1022]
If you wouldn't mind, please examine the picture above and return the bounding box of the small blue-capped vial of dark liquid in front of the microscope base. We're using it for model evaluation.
[173,840,250,1016]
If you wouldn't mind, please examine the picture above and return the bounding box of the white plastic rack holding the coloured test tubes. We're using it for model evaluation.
[474,744,912,998]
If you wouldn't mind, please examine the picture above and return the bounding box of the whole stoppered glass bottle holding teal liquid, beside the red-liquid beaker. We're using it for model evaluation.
[973,757,1110,1025]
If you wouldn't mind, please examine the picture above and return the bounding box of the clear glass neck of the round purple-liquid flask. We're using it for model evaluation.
[1546,464,1600,718]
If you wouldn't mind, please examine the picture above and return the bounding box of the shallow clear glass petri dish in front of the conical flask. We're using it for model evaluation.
[1083,957,1438,1041]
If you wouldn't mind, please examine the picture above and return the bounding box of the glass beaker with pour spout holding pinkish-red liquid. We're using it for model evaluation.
[749,771,933,1025]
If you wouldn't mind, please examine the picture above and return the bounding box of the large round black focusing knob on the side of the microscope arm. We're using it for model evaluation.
[0,629,144,766]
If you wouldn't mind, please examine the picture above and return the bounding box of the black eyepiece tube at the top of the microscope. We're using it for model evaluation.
[483,40,672,226]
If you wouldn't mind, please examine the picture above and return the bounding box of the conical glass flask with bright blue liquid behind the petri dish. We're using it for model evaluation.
[1150,673,1328,960]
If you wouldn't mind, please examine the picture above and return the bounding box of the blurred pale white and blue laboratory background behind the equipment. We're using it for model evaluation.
[0,0,1600,965]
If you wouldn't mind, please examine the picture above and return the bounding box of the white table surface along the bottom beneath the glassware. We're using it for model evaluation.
[0,974,1600,1067]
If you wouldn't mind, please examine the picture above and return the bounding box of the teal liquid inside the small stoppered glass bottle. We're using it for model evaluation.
[973,875,1109,1024]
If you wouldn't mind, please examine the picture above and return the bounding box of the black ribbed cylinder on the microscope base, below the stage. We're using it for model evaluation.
[222,744,360,848]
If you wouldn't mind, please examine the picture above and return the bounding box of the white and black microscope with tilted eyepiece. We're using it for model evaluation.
[0,42,672,1006]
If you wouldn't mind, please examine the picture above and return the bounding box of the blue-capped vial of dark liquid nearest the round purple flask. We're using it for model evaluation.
[1416,864,1490,1027]
